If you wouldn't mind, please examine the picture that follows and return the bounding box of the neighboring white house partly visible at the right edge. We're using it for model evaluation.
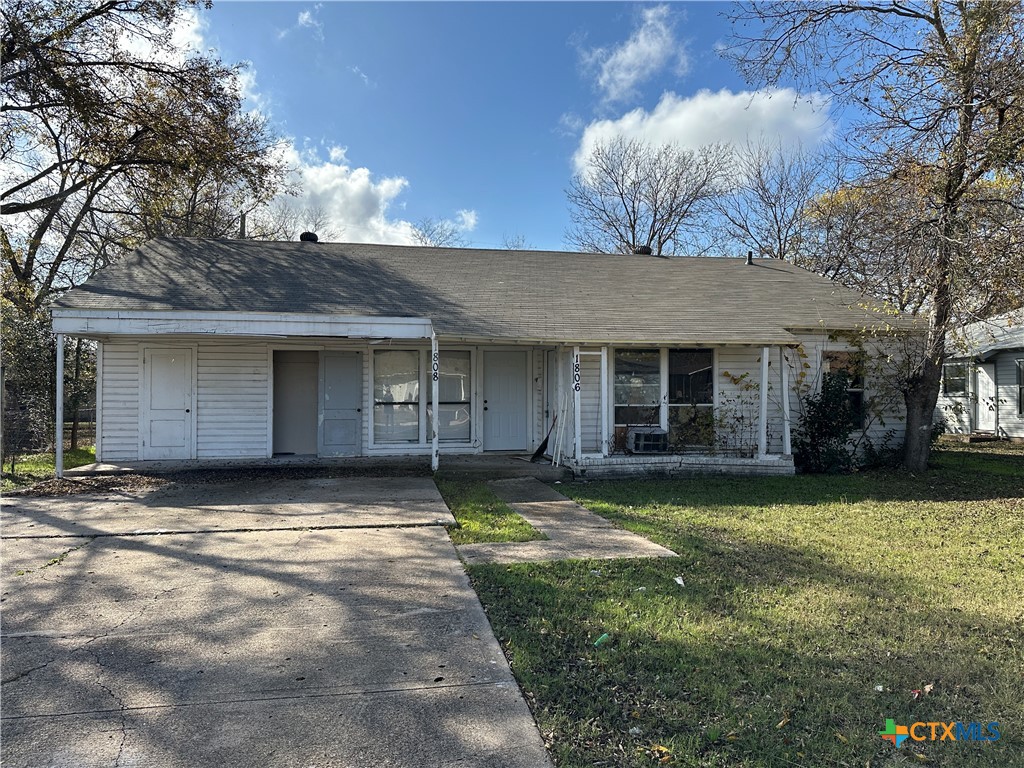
[935,308,1024,439]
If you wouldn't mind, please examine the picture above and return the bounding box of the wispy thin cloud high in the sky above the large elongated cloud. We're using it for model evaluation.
[584,5,689,102]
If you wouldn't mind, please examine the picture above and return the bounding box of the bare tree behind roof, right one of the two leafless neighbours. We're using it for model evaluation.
[714,141,841,262]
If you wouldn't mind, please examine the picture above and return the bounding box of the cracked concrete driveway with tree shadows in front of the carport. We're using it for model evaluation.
[0,478,550,768]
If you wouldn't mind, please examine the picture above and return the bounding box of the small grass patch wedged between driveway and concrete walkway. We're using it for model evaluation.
[435,476,547,544]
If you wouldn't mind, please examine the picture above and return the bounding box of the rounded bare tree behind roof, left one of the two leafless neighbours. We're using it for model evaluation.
[565,136,729,256]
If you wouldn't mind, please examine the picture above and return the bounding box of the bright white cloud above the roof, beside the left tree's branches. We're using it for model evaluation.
[284,143,417,244]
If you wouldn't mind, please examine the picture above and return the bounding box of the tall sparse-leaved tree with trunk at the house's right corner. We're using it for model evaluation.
[731,0,1024,471]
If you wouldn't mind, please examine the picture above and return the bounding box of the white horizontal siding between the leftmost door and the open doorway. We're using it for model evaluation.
[196,343,270,459]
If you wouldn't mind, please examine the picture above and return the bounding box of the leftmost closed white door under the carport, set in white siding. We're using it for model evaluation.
[140,347,195,460]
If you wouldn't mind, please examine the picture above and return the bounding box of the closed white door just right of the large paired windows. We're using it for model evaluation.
[483,351,527,451]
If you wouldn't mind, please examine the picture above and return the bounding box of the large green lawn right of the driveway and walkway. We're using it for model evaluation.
[469,445,1024,768]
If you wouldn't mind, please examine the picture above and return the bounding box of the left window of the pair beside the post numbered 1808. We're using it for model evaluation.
[374,349,420,442]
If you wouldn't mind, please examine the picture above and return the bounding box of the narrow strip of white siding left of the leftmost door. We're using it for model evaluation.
[96,342,140,462]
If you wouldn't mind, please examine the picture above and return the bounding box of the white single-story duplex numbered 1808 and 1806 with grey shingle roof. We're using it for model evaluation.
[52,239,899,476]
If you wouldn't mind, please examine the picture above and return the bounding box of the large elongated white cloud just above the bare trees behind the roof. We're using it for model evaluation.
[572,88,833,170]
